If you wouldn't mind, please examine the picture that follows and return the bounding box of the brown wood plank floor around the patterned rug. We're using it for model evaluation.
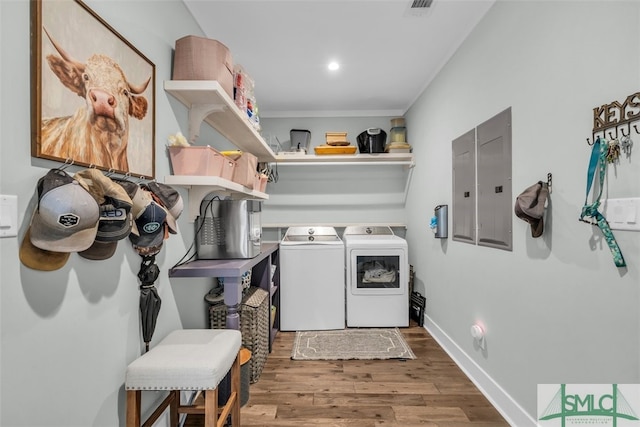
[186,323,509,427]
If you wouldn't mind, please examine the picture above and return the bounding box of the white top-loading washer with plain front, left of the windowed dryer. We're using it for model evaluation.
[280,226,345,331]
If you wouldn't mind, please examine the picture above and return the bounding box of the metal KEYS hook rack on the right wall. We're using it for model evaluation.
[587,92,640,146]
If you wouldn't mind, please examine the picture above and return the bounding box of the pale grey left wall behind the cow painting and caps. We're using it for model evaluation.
[0,0,205,427]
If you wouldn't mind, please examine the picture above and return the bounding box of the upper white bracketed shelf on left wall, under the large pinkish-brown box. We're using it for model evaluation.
[164,80,275,162]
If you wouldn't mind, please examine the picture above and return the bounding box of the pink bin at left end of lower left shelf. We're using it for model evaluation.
[169,145,233,179]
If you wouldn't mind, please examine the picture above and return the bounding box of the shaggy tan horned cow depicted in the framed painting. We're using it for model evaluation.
[40,29,151,172]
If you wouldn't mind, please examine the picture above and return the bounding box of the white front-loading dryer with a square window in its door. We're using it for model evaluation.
[342,226,409,327]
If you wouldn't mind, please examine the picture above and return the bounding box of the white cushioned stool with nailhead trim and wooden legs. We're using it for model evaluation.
[125,329,242,427]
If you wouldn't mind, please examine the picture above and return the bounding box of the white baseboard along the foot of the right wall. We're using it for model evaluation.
[424,314,538,427]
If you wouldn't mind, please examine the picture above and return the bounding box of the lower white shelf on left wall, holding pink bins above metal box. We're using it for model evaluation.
[164,175,269,222]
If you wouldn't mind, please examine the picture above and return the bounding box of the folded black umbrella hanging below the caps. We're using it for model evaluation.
[138,255,162,351]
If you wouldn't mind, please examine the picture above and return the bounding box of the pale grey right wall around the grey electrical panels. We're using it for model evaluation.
[406,1,640,426]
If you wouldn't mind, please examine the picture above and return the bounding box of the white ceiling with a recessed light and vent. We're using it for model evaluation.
[184,0,494,117]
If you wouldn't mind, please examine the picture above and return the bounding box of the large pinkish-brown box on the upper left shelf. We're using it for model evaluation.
[172,36,233,100]
